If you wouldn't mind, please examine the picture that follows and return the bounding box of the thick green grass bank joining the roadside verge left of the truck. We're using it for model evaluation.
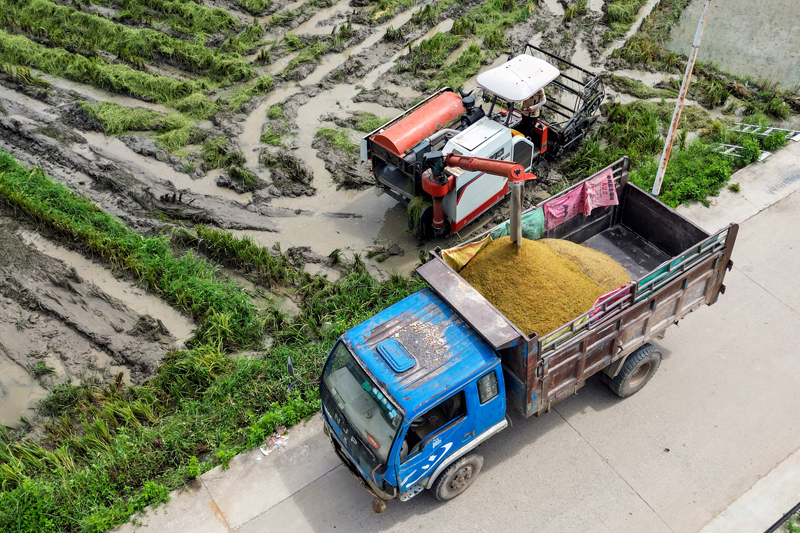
[0,149,422,533]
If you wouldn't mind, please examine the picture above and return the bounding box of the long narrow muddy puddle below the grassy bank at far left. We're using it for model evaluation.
[19,230,195,344]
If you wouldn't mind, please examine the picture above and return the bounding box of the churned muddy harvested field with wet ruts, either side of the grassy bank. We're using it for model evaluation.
[0,0,792,460]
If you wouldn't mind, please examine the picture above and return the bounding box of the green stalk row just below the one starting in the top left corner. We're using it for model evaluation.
[0,30,215,118]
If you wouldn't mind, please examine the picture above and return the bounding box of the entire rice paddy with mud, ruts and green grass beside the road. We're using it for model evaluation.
[0,0,800,532]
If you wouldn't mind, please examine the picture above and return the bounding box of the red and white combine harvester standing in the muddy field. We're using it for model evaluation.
[361,44,605,239]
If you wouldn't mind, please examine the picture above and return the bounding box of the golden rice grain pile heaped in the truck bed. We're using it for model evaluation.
[460,237,630,335]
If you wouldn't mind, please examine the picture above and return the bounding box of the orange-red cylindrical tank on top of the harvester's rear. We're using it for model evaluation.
[372,91,466,157]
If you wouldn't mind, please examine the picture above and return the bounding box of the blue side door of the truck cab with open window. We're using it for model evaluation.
[396,388,475,492]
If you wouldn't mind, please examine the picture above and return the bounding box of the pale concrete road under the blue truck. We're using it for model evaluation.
[121,144,800,533]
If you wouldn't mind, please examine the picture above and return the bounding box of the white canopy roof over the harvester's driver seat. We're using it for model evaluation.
[477,54,561,102]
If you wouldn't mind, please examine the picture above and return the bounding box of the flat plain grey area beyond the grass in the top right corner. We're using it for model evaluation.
[669,0,800,89]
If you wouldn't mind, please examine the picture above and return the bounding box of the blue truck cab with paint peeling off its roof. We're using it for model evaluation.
[320,289,507,501]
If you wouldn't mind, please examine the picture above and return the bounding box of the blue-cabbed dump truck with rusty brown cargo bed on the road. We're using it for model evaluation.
[320,158,738,504]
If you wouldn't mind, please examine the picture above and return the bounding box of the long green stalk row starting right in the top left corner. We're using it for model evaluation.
[0,0,253,83]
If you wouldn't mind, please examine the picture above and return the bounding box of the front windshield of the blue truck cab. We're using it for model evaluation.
[322,342,403,463]
